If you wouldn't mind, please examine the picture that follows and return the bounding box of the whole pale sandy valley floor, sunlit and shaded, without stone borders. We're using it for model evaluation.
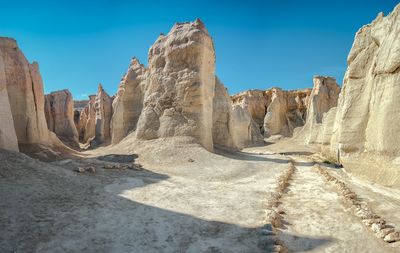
[0,137,400,253]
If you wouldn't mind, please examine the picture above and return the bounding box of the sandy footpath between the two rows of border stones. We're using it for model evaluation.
[279,159,395,252]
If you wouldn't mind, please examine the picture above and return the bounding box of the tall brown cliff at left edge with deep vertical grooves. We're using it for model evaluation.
[0,37,62,150]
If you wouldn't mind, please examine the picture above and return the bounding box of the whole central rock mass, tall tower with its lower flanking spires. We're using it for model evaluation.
[111,19,262,151]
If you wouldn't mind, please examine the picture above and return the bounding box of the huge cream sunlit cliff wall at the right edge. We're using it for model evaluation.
[331,5,400,187]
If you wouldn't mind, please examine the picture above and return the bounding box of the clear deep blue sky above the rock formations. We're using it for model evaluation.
[0,0,399,99]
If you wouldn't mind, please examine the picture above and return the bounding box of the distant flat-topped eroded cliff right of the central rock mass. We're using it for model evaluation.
[232,88,311,137]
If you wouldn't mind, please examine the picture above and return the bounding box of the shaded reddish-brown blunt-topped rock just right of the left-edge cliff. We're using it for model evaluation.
[45,90,79,146]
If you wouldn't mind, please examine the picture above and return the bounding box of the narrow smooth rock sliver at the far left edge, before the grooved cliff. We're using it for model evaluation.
[0,38,18,151]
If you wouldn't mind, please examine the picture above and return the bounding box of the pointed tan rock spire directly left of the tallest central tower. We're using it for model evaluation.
[111,58,148,144]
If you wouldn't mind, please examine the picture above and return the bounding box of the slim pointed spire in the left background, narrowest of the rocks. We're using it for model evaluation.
[95,84,113,143]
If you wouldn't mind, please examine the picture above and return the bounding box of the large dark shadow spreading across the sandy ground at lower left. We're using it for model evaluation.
[0,148,327,253]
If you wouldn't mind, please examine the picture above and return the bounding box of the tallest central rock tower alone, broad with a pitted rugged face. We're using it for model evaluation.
[136,19,215,150]
